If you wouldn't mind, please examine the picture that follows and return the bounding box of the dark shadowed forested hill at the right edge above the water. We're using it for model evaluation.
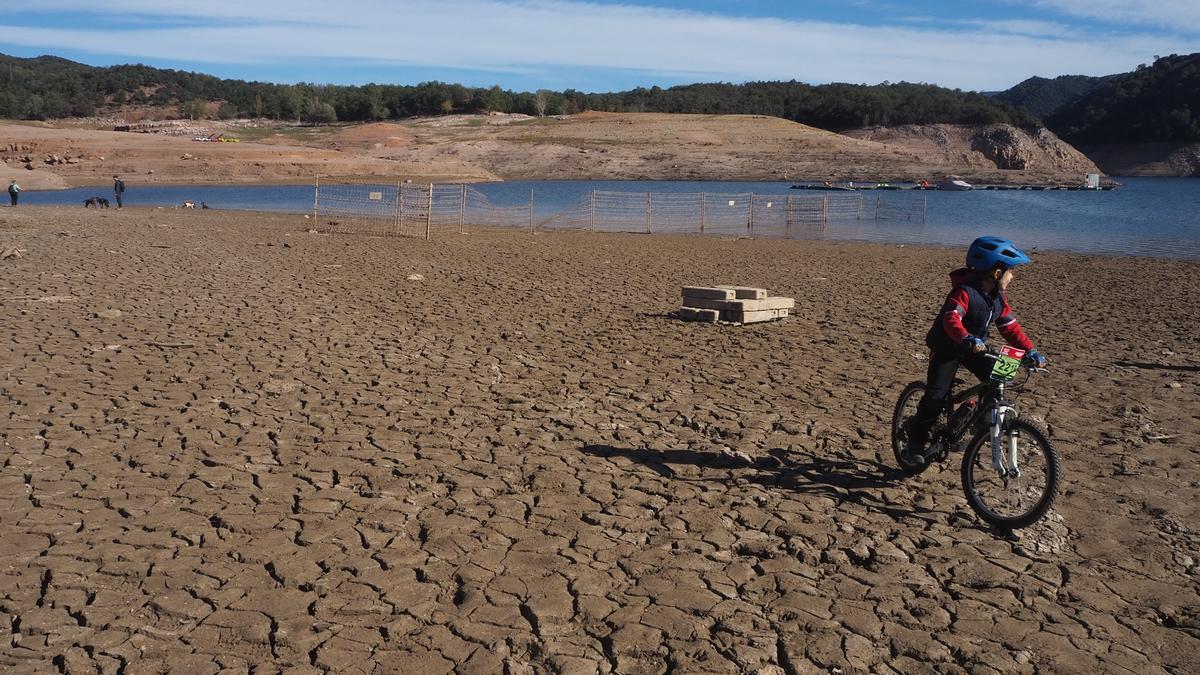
[1046,54,1200,144]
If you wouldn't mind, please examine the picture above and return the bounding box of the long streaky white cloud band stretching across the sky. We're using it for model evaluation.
[0,0,1187,90]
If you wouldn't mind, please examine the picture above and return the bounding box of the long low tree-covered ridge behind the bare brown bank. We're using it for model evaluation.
[0,55,1040,131]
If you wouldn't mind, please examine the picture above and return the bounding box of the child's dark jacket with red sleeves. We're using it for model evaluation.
[925,268,1033,353]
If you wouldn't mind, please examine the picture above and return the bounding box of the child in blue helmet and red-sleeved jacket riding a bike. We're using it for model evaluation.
[905,237,1046,464]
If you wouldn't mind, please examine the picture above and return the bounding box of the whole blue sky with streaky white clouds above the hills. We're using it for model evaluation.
[0,0,1200,91]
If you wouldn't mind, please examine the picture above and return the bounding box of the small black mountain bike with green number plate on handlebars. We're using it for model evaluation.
[892,346,1061,530]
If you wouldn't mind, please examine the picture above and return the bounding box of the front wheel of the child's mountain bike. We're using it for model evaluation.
[962,417,1060,530]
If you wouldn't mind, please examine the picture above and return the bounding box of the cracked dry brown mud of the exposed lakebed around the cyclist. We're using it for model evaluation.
[0,209,1200,674]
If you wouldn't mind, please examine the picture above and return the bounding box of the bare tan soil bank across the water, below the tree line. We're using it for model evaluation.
[0,113,1097,189]
